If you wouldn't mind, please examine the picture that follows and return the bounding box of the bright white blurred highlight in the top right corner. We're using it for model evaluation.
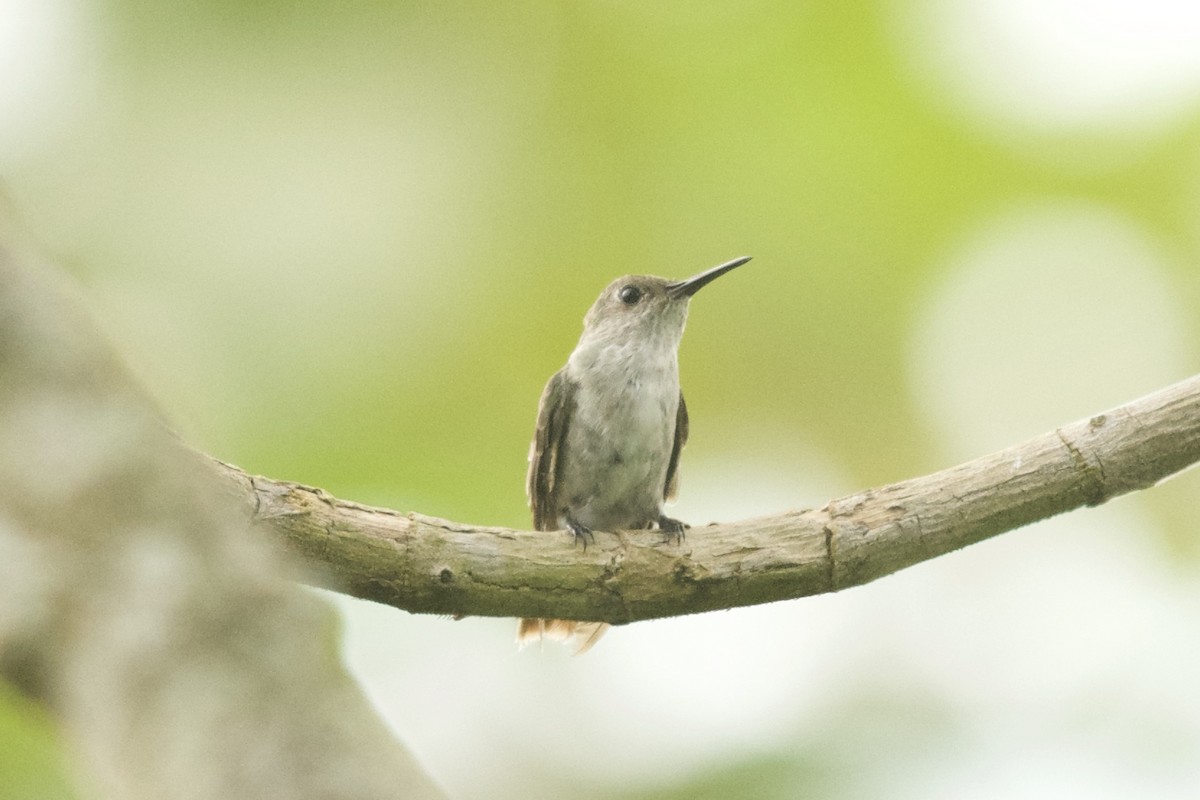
[893,0,1200,140]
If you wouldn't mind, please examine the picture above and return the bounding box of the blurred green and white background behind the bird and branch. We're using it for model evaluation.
[7,0,1200,799]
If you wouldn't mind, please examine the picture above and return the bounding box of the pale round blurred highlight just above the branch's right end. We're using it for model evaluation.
[911,203,1193,459]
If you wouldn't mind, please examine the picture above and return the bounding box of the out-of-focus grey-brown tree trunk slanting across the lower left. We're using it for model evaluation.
[0,231,440,800]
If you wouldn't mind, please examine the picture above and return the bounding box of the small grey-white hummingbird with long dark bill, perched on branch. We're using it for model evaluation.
[517,257,750,654]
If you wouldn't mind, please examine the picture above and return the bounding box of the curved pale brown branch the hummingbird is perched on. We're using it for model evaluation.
[216,369,1200,624]
